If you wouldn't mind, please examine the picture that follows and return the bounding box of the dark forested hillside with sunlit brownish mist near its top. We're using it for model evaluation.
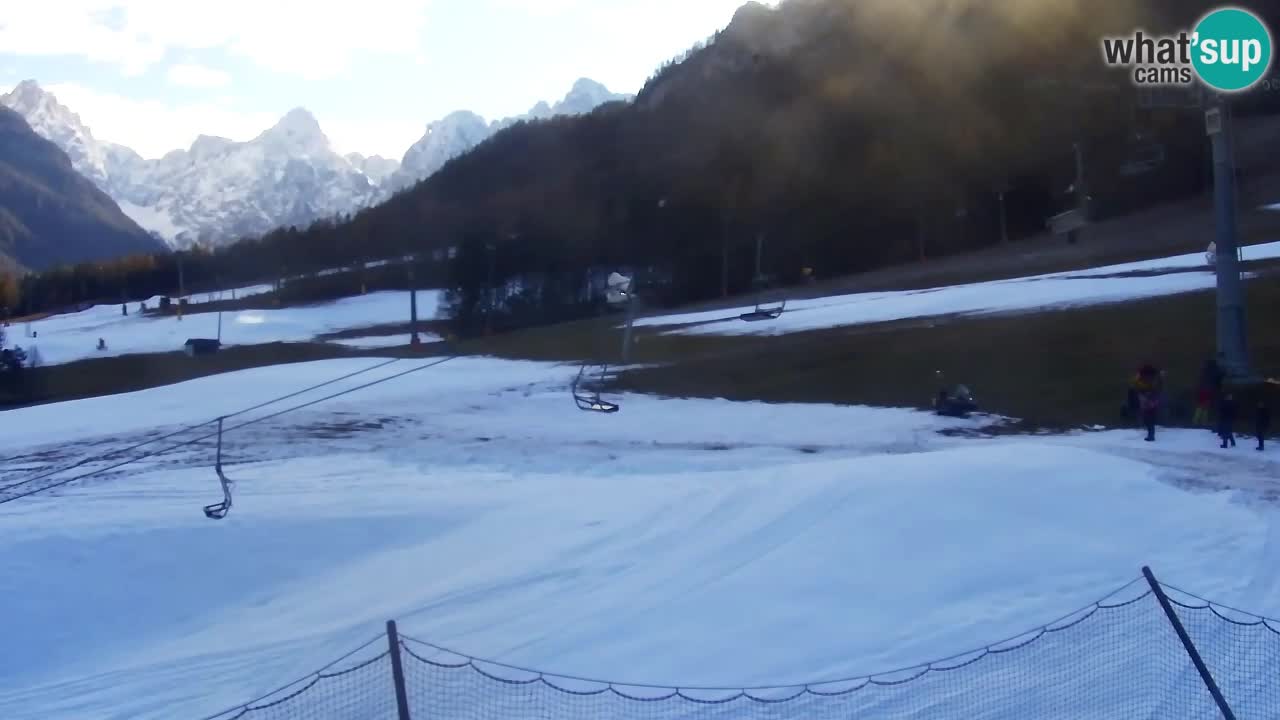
[10,0,1280,327]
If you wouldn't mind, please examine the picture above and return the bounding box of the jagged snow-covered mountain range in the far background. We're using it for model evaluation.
[0,78,630,247]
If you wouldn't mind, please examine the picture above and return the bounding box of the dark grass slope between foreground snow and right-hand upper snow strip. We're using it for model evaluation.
[474,266,1280,429]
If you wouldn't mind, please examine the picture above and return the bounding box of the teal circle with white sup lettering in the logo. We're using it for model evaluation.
[1192,8,1271,92]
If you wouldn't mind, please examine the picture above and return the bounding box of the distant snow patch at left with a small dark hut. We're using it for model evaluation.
[8,286,439,365]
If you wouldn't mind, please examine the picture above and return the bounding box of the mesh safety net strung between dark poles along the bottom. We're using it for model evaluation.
[197,579,1280,720]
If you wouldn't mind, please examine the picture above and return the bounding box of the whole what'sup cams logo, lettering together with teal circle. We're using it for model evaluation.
[1102,8,1271,92]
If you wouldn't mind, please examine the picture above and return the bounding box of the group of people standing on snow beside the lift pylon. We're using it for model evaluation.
[1128,354,1271,451]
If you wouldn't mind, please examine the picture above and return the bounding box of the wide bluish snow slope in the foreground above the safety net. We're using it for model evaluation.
[0,359,1280,720]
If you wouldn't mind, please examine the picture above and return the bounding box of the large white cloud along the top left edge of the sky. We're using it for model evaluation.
[0,0,431,78]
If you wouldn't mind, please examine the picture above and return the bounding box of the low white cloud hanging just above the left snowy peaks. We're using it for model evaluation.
[46,83,279,158]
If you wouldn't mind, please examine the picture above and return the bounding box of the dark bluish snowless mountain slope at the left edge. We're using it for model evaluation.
[0,108,164,270]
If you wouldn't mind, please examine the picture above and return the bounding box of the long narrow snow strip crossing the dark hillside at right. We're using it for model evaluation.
[635,242,1280,334]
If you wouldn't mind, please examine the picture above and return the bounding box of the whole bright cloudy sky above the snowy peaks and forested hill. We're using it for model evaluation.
[0,0,776,159]
